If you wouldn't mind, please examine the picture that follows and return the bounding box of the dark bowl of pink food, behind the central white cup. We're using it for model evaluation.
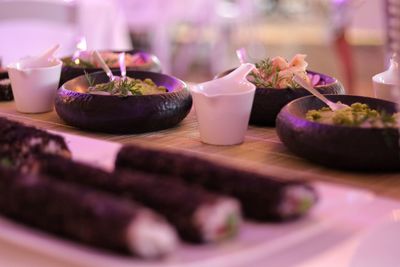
[216,69,345,126]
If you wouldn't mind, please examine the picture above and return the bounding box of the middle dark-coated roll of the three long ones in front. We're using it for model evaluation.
[25,155,241,243]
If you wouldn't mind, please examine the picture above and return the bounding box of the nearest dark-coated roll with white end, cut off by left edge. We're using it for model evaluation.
[0,168,176,257]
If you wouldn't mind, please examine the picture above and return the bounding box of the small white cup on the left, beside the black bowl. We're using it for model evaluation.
[7,58,62,113]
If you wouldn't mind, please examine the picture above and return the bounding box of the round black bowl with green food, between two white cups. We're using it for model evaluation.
[55,71,192,133]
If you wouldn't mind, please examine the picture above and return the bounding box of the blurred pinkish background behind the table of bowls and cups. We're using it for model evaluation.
[0,0,388,95]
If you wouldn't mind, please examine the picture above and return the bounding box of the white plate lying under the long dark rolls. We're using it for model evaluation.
[0,134,398,267]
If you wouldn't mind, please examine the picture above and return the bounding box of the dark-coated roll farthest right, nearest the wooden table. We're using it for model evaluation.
[115,145,317,221]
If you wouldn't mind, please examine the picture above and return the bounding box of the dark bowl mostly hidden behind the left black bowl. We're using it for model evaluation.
[60,49,161,85]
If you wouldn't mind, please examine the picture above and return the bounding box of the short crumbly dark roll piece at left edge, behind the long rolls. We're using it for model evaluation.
[0,117,71,170]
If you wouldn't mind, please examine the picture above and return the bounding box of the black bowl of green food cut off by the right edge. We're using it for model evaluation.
[276,95,400,171]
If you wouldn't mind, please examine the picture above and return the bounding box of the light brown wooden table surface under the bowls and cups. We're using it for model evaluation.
[0,102,400,199]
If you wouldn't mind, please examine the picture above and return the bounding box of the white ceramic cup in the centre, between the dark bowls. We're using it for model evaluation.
[191,73,256,145]
